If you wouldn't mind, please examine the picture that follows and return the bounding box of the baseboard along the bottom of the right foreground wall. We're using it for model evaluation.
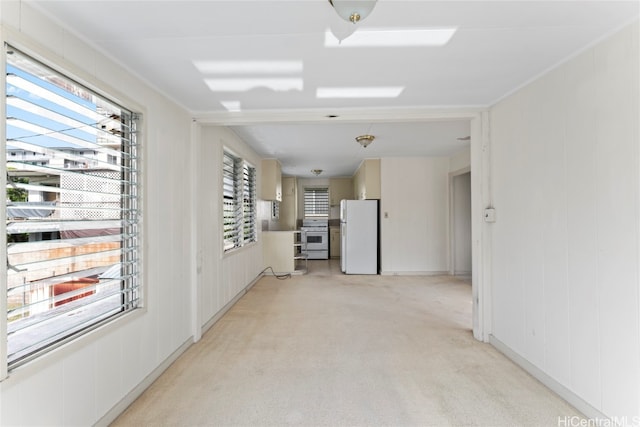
[489,335,610,425]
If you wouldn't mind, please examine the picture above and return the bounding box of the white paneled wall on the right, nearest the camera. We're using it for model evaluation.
[491,23,640,423]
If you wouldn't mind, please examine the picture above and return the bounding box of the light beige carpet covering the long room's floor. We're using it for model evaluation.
[113,262,579,426]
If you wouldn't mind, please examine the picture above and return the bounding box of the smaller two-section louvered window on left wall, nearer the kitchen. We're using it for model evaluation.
[222,151,256,251]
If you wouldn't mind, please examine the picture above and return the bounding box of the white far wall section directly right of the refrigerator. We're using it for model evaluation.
[380,157,449,274]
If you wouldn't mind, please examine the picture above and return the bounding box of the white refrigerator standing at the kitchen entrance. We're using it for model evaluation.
[340,200,378,274]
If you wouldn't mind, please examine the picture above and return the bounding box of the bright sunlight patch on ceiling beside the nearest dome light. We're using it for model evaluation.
[324,28,457,47]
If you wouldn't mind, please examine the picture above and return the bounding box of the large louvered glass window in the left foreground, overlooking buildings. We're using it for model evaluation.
[5,46,140,366]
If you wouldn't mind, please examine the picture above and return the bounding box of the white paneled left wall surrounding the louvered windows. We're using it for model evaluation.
[0,1,261,426]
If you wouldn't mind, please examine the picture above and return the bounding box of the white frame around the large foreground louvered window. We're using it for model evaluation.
[0,41,146,372]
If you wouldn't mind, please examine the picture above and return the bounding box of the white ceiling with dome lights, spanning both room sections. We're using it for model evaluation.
[31,0,639,176]
